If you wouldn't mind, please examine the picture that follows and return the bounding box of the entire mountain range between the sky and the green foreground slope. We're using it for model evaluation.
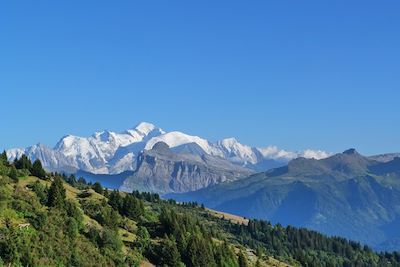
[7,123,400,250]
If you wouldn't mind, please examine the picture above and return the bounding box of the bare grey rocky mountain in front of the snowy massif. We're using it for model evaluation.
[120,142,251,194]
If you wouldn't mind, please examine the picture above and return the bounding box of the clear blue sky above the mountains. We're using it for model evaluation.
[0,0,400,154]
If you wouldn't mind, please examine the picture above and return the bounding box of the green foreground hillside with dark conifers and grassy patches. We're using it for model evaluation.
[0,153,400,267]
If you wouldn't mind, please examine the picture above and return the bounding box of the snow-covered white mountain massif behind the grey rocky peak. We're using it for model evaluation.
[7,122,330,174]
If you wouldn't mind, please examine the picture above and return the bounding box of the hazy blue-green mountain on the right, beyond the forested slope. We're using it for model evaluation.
[168,149,400,250]
